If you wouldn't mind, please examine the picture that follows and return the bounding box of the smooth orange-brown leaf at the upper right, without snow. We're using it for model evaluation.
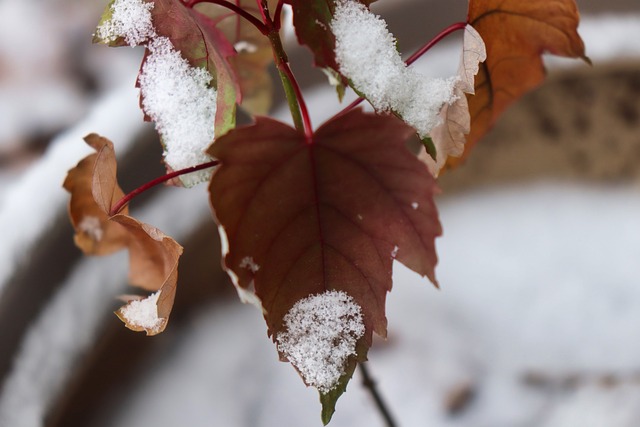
[448,0,589,166]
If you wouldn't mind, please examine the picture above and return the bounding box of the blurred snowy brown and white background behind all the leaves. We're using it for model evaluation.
[0,0,640,427]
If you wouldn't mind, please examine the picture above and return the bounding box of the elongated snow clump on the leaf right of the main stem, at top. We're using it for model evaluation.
[331,0,457,138]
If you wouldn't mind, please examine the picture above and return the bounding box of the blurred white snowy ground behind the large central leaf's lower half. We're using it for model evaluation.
[106,183,640,427]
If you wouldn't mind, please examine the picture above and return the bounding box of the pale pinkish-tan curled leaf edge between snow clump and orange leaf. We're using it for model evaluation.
[420,25,487,177]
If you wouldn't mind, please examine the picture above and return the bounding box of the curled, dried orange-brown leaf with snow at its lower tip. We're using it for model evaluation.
[64,134,182,335]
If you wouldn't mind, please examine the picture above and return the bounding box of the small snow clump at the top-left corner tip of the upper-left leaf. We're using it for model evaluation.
[96,0,156,46]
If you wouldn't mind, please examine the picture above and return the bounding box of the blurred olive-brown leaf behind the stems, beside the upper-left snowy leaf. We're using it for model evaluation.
[196,0,278,114]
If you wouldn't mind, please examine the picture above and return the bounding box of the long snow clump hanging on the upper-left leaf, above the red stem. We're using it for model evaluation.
[138,37,217,187]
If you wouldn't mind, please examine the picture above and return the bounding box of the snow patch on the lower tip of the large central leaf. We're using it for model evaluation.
[276,291,365,394]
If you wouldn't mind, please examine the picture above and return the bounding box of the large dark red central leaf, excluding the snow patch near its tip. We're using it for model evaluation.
[209,110,441,417]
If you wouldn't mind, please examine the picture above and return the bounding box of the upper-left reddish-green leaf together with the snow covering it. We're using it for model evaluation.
[95,0,239,186]
